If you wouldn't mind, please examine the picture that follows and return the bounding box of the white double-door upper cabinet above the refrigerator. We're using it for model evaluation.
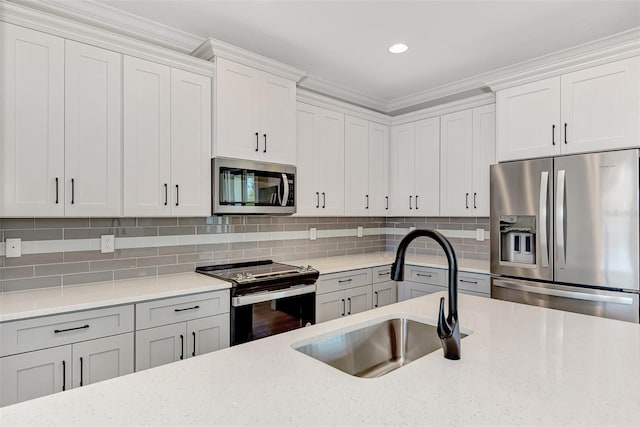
[496,57,640,161]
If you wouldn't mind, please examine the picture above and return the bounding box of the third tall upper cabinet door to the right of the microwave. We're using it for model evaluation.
[344,116,371,216]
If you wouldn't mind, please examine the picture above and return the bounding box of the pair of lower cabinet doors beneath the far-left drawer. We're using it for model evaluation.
[0,332,133,406]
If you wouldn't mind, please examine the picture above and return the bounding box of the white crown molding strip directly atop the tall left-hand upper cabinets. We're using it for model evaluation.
[0,2,215,77]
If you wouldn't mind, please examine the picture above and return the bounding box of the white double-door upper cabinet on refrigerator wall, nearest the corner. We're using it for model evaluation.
[389,117,440,216]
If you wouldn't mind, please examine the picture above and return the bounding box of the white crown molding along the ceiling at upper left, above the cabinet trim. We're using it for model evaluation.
[8,0,203,54]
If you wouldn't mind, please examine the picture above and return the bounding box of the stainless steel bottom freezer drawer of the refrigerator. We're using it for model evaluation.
[491,278,640,323]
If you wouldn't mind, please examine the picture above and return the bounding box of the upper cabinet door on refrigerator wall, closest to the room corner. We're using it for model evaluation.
[389,123,415,216]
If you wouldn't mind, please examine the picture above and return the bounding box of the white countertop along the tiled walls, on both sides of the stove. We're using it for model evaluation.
[0,252,489,322]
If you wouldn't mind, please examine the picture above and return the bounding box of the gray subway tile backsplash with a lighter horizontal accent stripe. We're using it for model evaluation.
[0,216,489,292]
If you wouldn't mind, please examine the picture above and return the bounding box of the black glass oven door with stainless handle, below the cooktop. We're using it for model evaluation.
[231,285,316,345]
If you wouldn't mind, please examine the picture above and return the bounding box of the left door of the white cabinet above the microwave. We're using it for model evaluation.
[214,58,263,160]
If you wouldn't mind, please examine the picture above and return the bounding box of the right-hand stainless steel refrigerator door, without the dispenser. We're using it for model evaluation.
[553,149,639,290]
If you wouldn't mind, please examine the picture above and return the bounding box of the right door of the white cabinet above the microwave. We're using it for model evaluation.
[258,73,296,165]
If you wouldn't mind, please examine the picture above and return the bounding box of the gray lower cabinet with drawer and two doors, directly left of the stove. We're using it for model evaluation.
[136,290,230,371]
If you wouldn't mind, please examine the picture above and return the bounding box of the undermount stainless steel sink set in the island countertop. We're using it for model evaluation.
[294,317,467,378]
